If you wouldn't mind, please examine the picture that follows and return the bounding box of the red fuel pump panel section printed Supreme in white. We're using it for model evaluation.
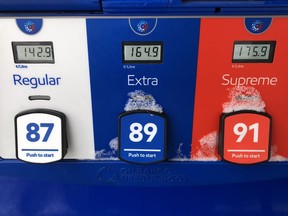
[191,17,288,164]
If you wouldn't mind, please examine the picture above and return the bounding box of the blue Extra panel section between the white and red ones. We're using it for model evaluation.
[87,18,200,158]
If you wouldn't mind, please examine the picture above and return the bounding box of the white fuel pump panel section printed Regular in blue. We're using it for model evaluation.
[0,18,95,162]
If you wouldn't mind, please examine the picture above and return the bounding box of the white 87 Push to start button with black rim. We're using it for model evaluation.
[15,109,67,163]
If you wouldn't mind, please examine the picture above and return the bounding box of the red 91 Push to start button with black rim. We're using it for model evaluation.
[219,111,271,164]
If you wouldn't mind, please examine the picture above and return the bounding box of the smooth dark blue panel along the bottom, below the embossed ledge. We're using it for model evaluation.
[0,177,288,216]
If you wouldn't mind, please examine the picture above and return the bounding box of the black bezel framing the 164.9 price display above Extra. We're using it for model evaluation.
[122,41,164,64]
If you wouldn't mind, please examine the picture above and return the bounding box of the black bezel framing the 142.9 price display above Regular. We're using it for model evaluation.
[12,41,55,64]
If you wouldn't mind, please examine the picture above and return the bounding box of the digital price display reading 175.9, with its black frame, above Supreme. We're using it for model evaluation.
[232,41,276,63]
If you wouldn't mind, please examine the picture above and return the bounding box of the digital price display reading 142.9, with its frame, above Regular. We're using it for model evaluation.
[12,41,55,64]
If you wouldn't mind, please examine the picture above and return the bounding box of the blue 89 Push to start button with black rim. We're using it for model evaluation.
[119,111,166,163]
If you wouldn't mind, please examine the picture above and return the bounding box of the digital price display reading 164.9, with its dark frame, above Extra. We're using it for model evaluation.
[122,42,163,63]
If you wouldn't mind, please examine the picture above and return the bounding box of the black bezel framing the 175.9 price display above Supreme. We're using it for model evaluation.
[232,41,276,63]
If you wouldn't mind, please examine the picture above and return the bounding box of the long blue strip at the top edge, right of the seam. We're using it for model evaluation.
[102,0,288,15]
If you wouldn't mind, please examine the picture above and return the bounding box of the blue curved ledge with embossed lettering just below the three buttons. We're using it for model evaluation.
[0,160,288,187]
